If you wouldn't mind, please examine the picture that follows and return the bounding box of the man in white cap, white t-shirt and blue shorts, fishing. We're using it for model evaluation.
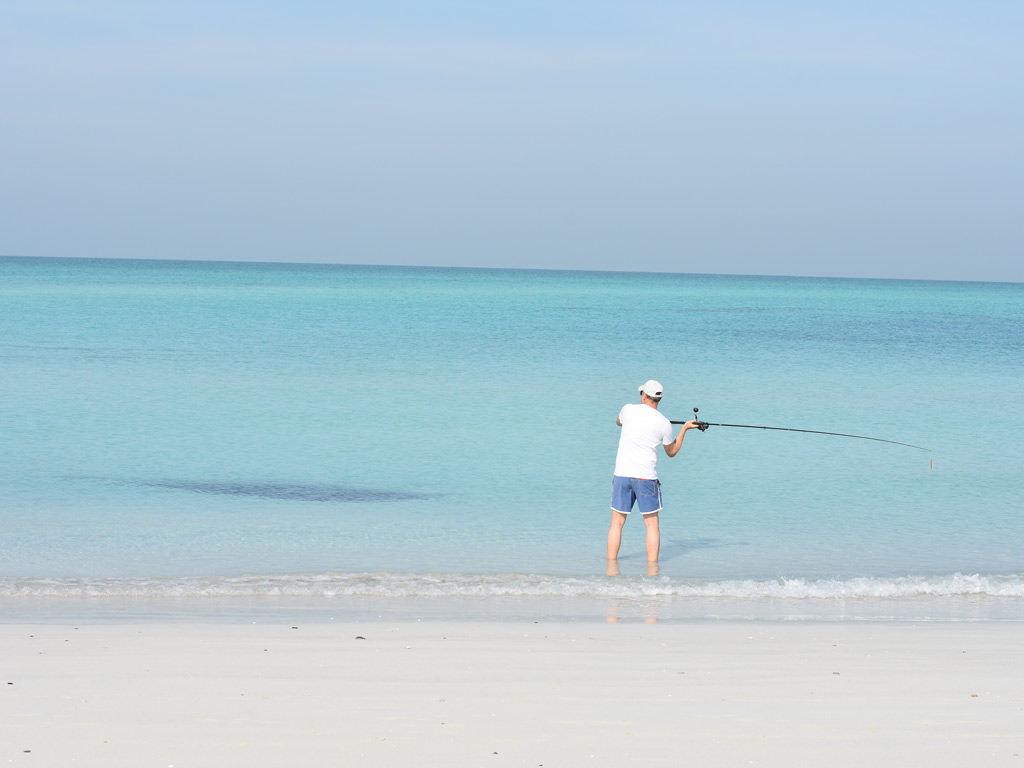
[608,379,697,563]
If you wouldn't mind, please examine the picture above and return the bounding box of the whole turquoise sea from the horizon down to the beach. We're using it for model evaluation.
[0,258,1024,621]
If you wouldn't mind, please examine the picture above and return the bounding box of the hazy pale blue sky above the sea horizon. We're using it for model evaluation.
[0,0,1024,282]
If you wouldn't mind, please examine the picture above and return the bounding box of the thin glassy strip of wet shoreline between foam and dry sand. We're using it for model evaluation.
[0,595,1024,626]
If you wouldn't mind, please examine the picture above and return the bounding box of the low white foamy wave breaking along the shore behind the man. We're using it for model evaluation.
[0,572,1024,601]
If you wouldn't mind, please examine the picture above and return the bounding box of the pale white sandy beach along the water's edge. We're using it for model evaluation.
[0,621,1024,768]
